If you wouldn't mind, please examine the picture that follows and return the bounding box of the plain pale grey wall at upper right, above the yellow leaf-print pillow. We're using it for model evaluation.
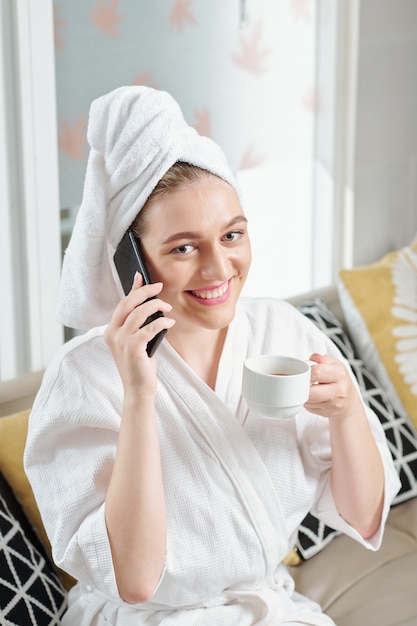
[354,0,417,265]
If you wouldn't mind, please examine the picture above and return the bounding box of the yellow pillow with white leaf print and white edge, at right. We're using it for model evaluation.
[339,238,417,428]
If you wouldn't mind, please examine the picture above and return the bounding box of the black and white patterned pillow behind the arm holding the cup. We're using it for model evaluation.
[296,298,417,559]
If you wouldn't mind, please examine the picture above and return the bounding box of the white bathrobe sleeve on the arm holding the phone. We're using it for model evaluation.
[24,330,121,596]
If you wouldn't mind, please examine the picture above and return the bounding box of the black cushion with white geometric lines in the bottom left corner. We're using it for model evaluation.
[0,494,67,626]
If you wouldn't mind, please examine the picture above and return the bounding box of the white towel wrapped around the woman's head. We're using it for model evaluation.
[57,87,237,329]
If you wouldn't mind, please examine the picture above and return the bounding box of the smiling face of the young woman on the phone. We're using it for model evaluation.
[142,176,251,332]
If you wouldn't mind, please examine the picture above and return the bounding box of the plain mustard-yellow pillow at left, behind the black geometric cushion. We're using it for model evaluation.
[0,410,74,589]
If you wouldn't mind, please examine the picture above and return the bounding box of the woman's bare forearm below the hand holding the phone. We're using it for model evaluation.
[105,397,166,603]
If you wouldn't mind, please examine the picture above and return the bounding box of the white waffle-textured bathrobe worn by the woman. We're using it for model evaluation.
[25,299,399,626]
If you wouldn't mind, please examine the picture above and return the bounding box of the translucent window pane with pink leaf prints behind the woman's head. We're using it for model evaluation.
[55,0,316,296]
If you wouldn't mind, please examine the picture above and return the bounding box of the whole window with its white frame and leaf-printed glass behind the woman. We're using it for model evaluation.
[0,0,355,378]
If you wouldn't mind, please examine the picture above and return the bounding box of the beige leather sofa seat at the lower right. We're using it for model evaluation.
[291,499,417,626]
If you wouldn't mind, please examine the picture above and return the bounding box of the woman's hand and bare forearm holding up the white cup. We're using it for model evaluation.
[304,354,384,539]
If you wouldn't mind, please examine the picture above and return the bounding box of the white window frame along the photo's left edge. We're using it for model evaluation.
[0,0,62,380]
